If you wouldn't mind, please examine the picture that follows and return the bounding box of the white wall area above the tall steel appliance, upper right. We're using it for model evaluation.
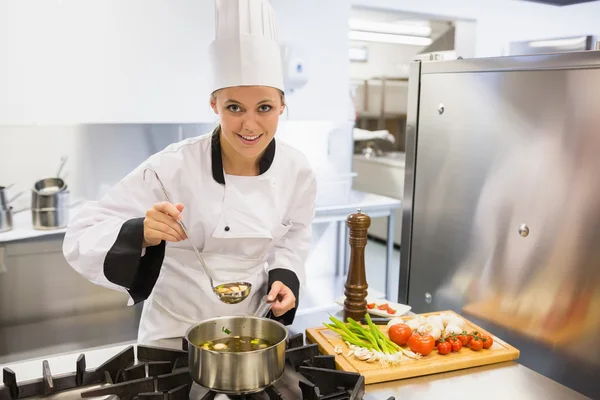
[350,0,600,57]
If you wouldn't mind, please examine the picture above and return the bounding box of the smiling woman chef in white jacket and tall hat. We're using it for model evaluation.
[63,0,316,343]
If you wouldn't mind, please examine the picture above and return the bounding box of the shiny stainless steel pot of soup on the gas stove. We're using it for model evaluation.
[185,296,288,395]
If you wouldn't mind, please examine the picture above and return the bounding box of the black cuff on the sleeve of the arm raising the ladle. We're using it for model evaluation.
[104,218,166,303]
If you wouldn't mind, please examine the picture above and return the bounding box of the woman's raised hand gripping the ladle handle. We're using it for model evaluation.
[143,201,187,247]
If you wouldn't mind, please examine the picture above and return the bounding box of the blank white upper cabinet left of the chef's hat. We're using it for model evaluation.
[0,0,215,125]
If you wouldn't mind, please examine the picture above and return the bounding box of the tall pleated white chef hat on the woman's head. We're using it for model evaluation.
[209,0,284,93]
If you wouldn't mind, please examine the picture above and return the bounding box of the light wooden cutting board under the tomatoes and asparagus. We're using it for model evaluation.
[306,311,520,385]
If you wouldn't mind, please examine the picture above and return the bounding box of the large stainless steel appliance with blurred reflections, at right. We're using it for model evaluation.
[399,51,600,398]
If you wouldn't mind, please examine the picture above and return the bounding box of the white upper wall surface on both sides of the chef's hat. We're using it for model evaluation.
[0,0,349,124]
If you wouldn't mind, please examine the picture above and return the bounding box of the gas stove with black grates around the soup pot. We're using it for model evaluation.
[0,333,365,400]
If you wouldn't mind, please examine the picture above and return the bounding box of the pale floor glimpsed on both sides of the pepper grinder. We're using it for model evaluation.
[298,240,400,312]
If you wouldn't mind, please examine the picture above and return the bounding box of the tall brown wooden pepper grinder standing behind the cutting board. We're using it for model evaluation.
[344,209,371,321]
